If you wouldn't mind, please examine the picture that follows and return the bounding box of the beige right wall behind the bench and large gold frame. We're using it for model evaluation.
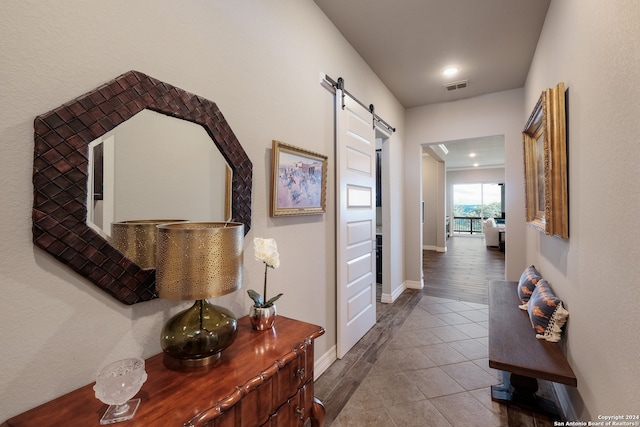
[521,0,640,420]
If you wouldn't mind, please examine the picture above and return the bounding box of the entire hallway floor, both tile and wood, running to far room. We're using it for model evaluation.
[316,237,553,427]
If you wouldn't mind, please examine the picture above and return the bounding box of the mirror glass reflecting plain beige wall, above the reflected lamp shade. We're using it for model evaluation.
[87,109,231,239]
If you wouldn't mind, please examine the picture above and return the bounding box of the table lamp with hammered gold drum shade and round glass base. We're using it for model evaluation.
[156,222,244,367]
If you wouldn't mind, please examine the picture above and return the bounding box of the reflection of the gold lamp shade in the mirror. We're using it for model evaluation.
[111,219,184,268]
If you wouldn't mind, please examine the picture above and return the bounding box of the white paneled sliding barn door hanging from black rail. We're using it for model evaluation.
[335,89,376,358]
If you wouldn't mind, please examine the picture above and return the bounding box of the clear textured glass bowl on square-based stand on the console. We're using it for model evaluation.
[93,358,147,425]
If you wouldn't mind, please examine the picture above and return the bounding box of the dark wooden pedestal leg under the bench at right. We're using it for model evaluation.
[491,371,560,419]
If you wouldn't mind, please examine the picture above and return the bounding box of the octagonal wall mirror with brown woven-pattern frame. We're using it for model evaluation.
[32,70,253,304]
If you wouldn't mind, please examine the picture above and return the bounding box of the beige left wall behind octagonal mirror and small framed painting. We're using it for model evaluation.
[0,0,404,421]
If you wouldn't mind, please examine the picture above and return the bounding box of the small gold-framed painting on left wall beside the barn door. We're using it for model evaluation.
[270,140,327,217]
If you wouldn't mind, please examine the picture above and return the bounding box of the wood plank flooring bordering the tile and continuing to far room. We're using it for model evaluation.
[315,237,552,427]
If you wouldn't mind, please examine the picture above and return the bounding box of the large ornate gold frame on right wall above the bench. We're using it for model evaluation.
[522,83,569,239]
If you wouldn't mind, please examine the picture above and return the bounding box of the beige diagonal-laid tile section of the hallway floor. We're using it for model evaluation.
[331,296,508,427]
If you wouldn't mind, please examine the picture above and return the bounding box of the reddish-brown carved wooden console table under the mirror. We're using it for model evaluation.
[2,316,325,427]
